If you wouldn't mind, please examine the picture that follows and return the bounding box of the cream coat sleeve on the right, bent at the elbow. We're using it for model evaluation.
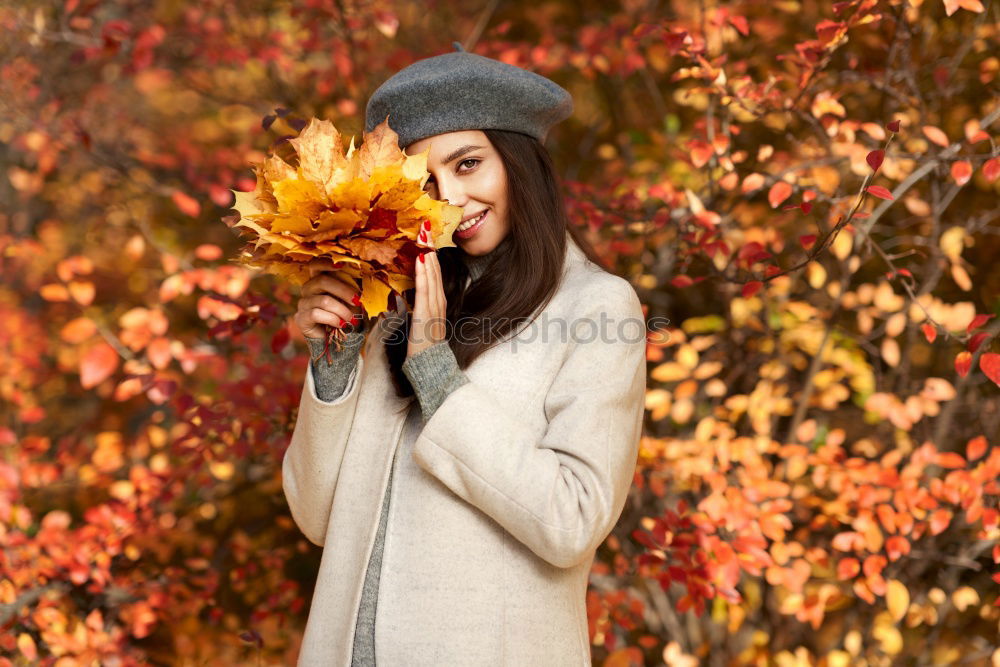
[413,278,646,567]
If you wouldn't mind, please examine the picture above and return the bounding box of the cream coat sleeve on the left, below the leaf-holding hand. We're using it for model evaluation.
[281,340,366,546]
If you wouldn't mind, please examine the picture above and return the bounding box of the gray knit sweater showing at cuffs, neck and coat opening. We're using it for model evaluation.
[306,255,490,667]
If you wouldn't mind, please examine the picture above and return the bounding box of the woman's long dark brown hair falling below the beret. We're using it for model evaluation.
[384,130,606,398]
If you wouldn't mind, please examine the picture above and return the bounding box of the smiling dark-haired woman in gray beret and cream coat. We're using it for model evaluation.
[282,43,646,666]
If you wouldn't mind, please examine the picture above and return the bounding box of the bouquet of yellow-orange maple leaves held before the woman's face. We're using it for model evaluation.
[227,118,462,362]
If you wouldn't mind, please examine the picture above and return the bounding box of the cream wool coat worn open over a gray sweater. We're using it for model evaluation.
[282,235,646,667]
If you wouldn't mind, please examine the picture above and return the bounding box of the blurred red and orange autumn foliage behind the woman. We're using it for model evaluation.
[0,0,1000,667]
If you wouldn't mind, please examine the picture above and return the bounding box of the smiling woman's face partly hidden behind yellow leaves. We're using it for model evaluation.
[405,130,510,255]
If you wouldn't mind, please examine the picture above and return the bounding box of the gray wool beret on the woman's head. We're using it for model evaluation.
[365,42,573,148]
